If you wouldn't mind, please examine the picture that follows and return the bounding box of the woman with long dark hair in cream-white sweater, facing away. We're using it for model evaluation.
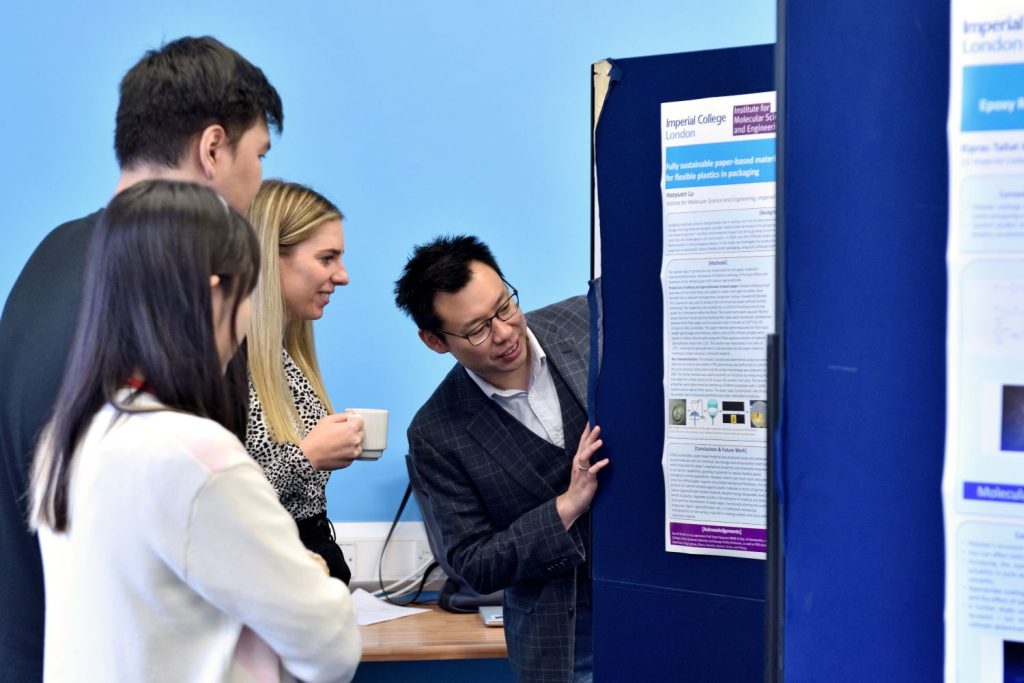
[30,180,360,682]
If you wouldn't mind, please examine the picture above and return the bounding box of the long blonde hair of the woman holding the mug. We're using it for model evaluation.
[248,180,344,443]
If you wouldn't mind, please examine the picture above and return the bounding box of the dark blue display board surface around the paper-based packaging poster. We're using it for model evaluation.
[592,45,774,681]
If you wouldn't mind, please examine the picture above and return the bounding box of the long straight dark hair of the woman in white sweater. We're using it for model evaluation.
[33,180,259,531]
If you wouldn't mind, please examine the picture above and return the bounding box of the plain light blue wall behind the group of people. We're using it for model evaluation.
[0,0,775,521]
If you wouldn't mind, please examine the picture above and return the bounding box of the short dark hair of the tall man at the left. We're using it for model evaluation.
[114,36,285,169]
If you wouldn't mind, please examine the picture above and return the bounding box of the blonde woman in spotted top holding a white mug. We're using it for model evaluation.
[246,180,362,583]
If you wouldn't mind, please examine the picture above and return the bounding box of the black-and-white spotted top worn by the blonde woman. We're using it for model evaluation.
[246,349,331,519]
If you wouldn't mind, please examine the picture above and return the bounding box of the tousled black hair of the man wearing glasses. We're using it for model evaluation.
[394,234,505,332]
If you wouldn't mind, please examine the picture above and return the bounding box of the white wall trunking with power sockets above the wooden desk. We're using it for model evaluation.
[334,522,444,592]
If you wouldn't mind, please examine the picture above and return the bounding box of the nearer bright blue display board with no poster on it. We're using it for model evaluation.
[772,0,949,682]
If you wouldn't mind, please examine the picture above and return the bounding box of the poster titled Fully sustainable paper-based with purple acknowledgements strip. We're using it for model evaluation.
[662,92,775,559]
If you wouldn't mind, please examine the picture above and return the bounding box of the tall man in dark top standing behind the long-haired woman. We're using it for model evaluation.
[0,37,284,683]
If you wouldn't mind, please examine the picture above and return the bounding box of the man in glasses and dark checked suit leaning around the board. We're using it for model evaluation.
[395,237,608,682]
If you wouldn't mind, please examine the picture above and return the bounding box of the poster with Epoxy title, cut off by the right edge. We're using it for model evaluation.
[942,0,1024,683]
